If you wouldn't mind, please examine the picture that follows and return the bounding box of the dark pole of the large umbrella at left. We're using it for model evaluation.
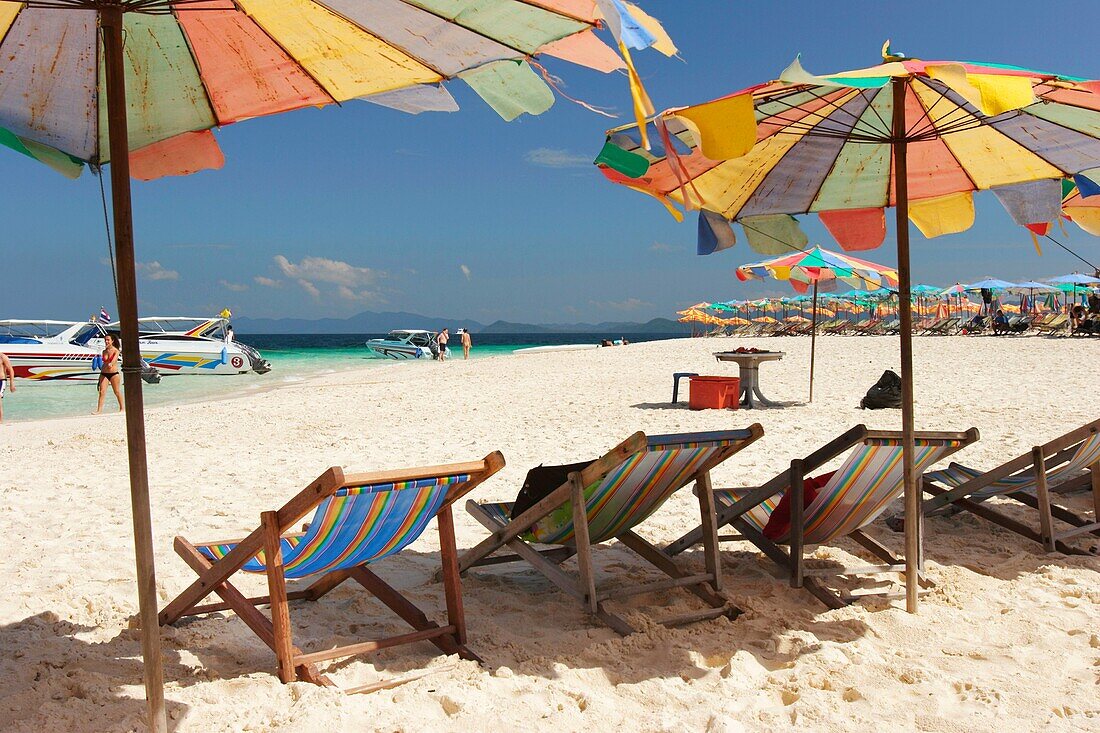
[99,3,168,733]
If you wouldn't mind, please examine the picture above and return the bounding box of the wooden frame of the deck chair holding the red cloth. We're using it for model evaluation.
[664,425,978,609]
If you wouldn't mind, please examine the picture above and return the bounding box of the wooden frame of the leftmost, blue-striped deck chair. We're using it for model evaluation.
[160,451,504,693]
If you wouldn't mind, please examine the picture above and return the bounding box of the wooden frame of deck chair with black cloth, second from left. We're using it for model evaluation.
[459,424,763,636]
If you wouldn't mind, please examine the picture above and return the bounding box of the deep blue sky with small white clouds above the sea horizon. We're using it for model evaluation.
[0,0,1100,327]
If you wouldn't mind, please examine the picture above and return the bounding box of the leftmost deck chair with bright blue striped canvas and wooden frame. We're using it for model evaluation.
[160,452,504,692]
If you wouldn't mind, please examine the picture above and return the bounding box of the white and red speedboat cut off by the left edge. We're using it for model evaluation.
[0,320,160,383]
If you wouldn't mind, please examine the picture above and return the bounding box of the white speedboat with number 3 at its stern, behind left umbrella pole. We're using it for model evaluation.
[88,316,272,374]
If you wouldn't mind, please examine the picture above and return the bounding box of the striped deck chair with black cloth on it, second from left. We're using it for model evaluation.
[459,424,763,635]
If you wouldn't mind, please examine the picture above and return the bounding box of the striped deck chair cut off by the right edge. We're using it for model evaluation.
[915,419,1100,555]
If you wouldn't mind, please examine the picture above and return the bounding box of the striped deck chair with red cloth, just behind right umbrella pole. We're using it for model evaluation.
[666,425,978,609]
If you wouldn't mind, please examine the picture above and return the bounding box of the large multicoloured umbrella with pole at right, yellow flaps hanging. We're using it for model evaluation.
[596,43,1100,611]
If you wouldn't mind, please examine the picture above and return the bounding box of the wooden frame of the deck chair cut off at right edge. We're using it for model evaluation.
[919,419,1100,555]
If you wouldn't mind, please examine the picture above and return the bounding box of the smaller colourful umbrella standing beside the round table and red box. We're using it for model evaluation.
[735,247,898,402]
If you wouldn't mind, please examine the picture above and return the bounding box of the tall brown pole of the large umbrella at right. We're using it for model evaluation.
[891,77,924,613]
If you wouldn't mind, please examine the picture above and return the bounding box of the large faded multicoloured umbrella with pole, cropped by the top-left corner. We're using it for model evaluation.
[0,0,675,732]
